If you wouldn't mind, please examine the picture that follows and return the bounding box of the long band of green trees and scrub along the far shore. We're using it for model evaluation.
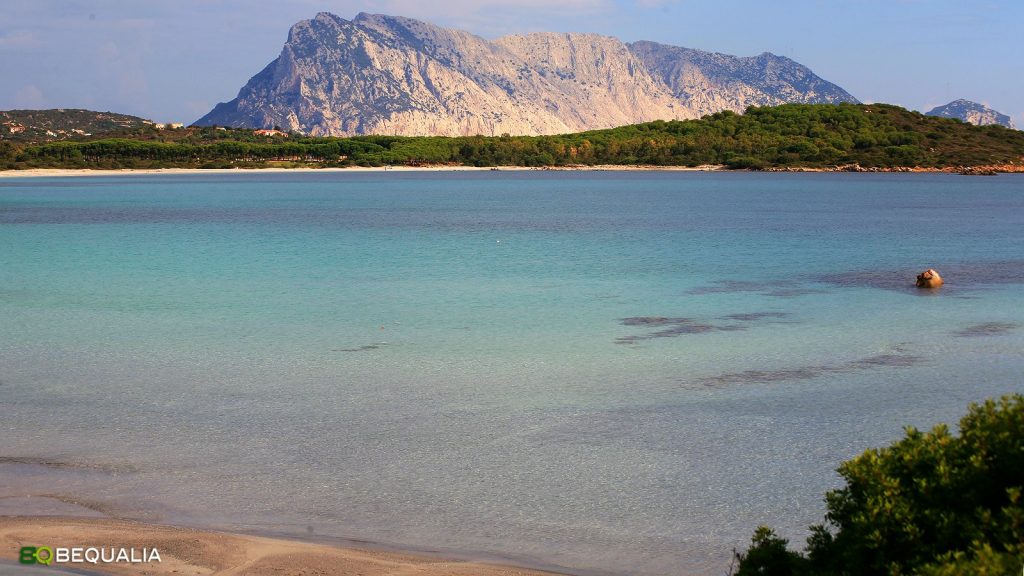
[0,104,1024,169]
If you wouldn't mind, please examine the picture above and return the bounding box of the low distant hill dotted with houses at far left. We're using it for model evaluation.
[0,109,153,141]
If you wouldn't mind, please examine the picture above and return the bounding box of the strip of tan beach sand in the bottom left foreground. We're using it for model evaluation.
[0,517,569,576]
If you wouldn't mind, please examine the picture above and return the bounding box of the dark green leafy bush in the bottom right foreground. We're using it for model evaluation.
[737,395,1024,576]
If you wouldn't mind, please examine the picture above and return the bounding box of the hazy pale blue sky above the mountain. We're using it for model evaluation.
[0,0,1024,127]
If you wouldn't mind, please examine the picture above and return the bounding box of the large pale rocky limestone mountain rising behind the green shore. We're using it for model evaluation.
[196,12,857,135]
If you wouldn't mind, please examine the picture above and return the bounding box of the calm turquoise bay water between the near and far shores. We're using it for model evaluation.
[0,171,1024,574]
